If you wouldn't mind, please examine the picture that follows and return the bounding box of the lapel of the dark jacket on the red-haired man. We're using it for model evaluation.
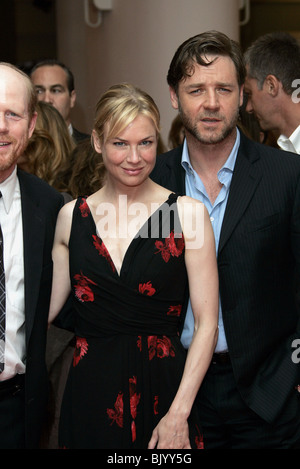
[18,173,45,342]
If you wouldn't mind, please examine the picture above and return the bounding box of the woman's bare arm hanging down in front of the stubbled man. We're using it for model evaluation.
[148,197,219,449]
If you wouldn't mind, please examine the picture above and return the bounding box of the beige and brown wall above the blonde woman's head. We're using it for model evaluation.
[56,0,239,142]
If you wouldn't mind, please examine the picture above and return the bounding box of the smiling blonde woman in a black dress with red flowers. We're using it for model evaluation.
[49,84,218,449]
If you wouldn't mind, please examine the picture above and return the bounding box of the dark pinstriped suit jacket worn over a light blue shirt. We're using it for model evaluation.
[151,130,300,422]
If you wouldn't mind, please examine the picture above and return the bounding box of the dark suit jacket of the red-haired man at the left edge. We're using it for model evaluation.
[18,170,63,448]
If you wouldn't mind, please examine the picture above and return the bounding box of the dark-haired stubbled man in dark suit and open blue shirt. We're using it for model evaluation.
[151,31,300,449]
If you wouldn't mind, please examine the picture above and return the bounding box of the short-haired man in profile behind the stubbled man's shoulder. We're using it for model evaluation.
[245,32,300,154]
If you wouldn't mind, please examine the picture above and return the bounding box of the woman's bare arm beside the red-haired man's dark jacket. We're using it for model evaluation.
[48,201,75,324]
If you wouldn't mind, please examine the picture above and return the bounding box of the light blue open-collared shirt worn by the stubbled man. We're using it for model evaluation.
[181,129,240,352]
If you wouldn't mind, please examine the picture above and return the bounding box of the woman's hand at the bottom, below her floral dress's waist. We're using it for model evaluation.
[148,412,191,449]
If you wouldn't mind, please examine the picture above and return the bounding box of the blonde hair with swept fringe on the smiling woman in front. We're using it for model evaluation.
[94,83,160,143]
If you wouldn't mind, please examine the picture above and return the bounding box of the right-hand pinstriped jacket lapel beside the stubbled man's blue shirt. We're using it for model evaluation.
[218,135,262,254]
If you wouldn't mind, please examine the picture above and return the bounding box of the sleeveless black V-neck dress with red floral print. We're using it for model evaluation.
[59,194,203,449]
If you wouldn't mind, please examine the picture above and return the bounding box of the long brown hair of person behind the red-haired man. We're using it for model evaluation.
[24,101,75,191]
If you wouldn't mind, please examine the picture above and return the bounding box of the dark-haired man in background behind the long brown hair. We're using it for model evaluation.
[30,60,89,143]
